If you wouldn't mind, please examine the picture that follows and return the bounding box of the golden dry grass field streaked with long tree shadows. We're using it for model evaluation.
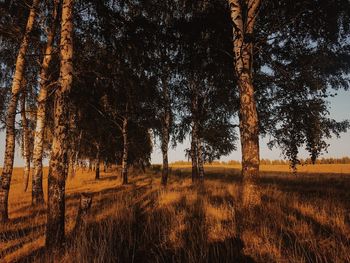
[0,165,350,262]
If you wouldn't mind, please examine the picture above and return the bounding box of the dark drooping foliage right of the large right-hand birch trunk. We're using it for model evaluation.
[255,0,350,168]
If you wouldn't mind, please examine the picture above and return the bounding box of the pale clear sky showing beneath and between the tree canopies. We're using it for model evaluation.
[0,91,350,167]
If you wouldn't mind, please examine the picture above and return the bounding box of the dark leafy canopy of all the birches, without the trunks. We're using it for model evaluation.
[0,0,350,168]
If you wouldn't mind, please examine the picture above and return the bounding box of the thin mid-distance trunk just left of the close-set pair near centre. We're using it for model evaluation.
[161,80,171,186]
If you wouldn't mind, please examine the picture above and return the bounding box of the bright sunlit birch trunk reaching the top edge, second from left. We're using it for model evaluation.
[32,0,59,206]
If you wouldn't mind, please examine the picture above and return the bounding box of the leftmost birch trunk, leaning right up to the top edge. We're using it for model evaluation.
[0,0,39,221]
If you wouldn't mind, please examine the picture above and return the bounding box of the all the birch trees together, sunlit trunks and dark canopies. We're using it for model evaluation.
[0,0,350,250]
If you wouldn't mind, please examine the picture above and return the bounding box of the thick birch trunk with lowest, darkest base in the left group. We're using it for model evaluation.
[46,0,74,248]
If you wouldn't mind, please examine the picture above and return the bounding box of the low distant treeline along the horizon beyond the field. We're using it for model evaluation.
[171,156,350,165]
